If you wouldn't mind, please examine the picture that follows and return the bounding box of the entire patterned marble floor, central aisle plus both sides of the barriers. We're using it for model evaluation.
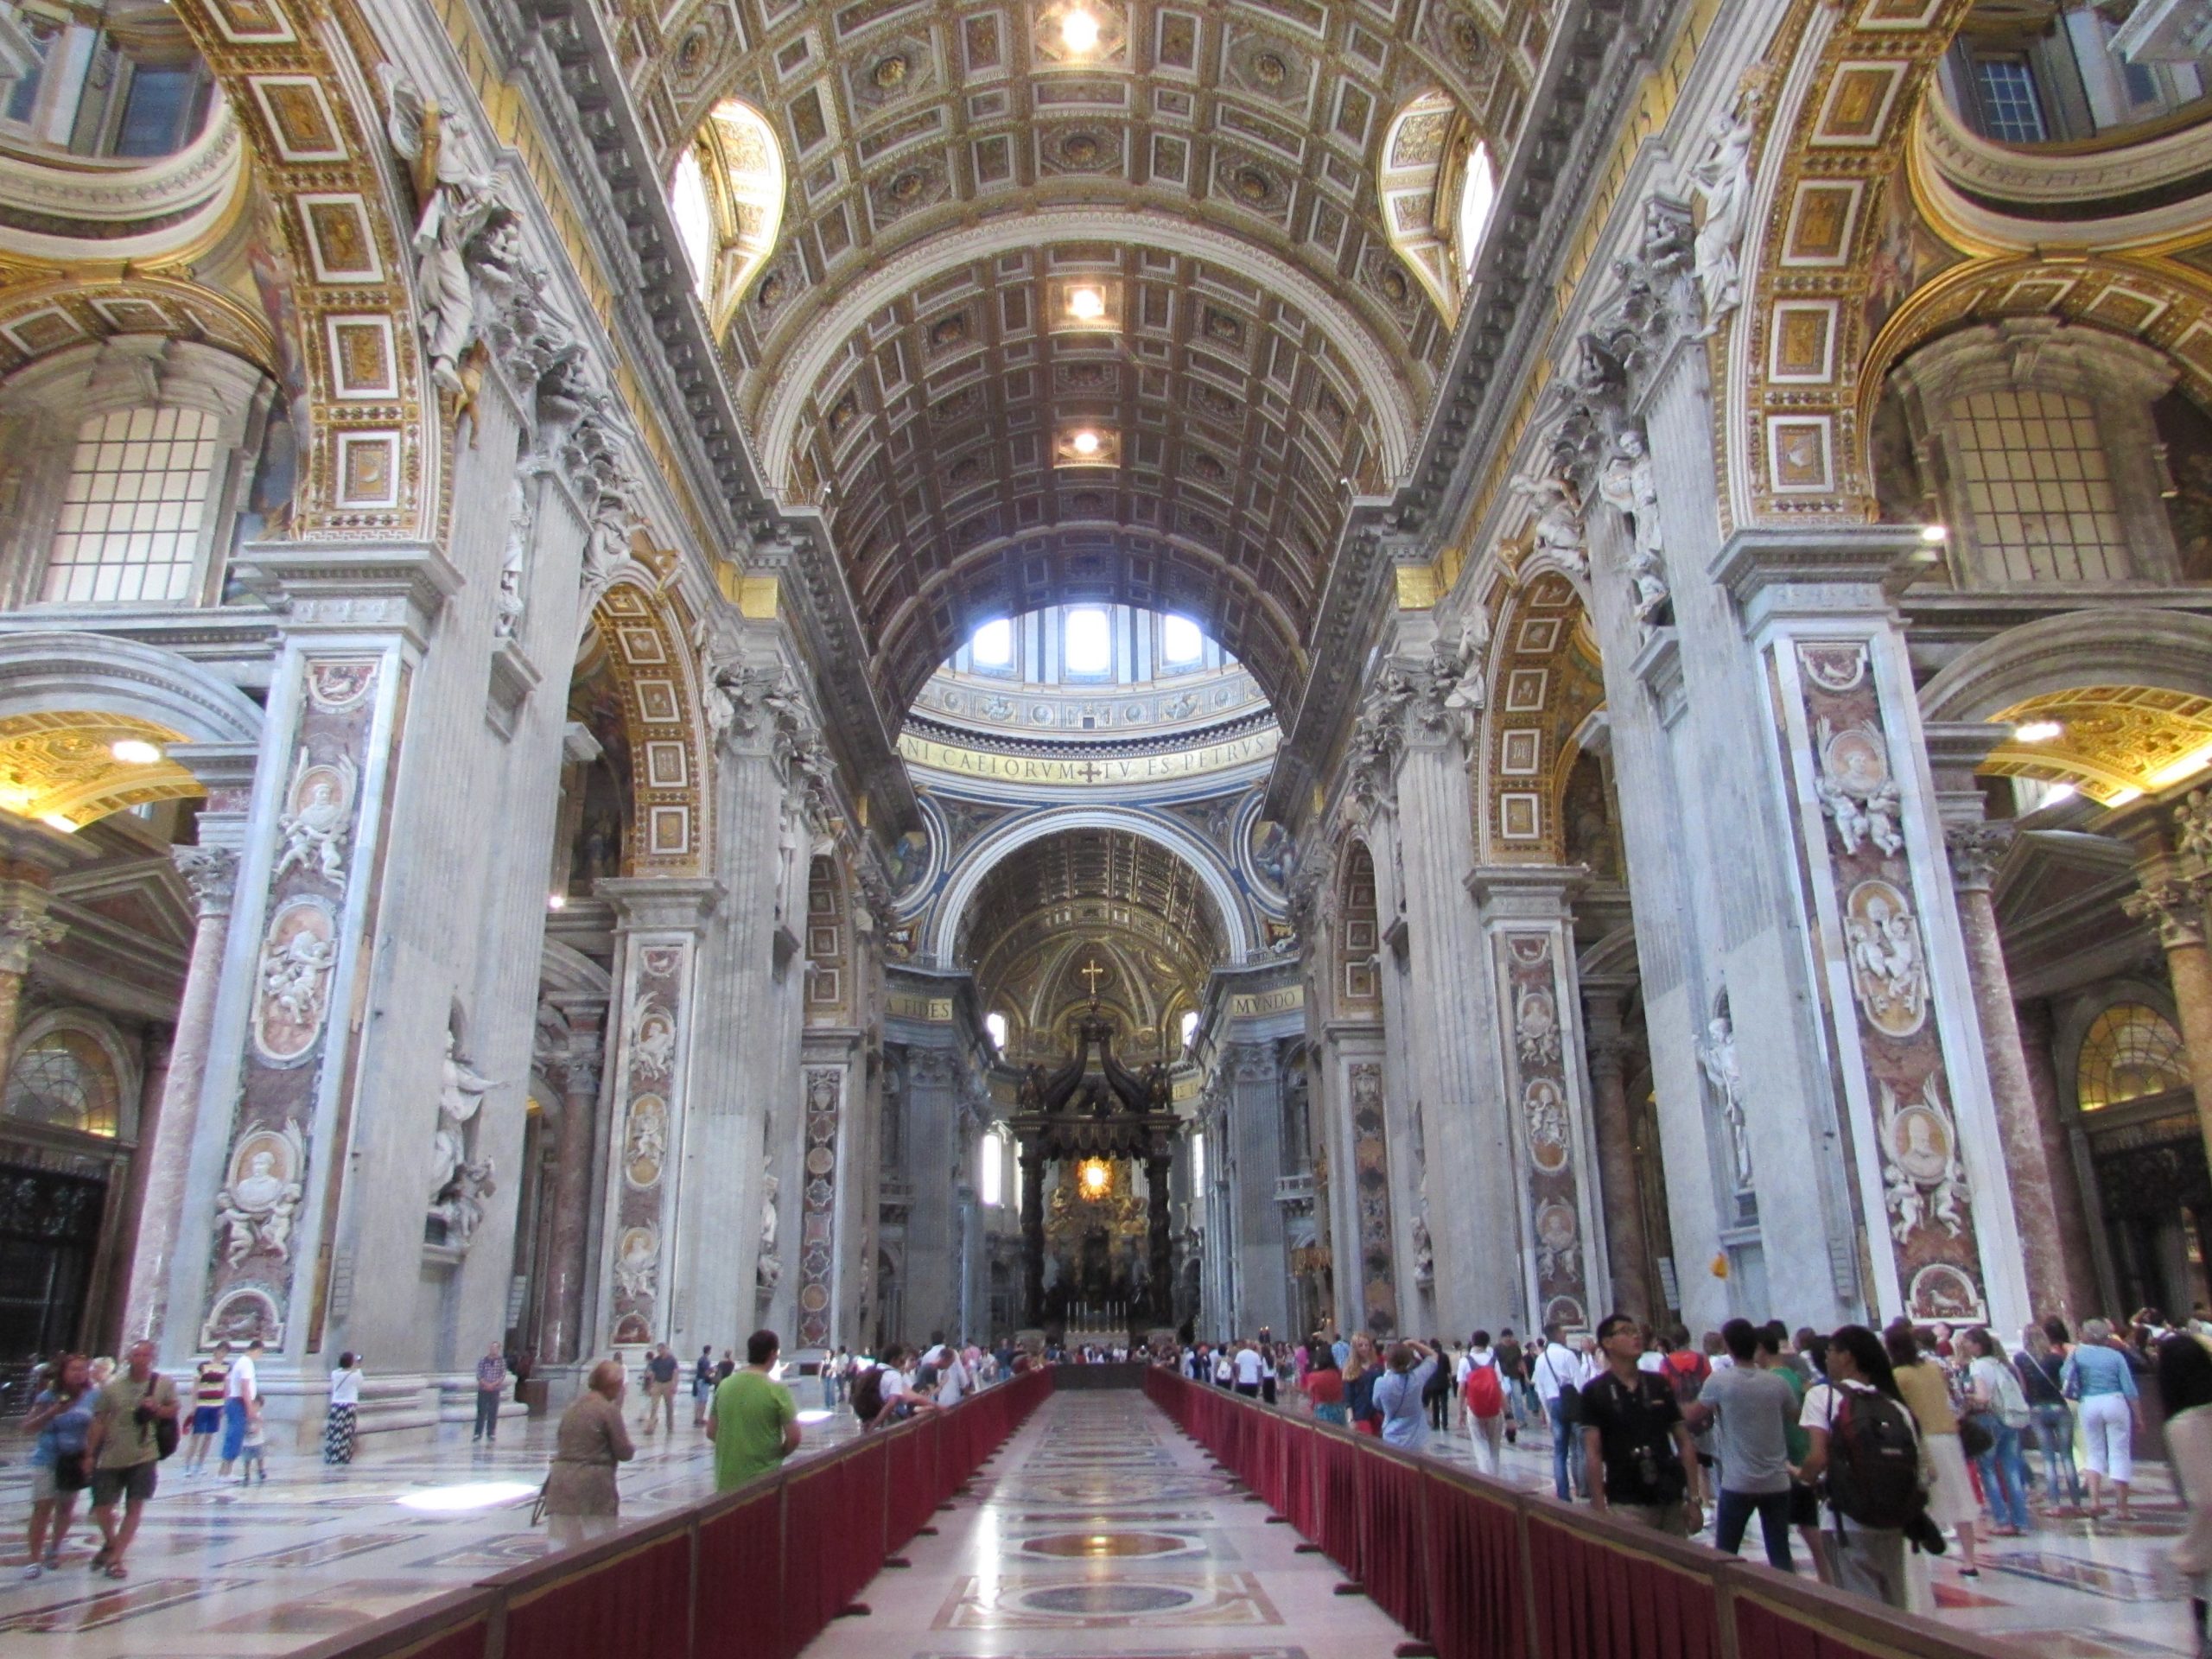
[0,1394,2192,1659]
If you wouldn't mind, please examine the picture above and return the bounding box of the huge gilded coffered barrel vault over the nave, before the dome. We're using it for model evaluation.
[617,0,1548,708]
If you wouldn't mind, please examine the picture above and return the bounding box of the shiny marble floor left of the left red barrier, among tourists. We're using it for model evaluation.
[0,1400,854,1659]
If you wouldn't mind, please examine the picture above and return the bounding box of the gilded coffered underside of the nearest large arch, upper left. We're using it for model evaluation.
[177,0,442,537]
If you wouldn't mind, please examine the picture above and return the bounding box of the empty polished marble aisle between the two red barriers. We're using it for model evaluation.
[805,1394,1405,1659]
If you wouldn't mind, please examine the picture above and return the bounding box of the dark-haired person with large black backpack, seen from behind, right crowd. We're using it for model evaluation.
[1798,1325,1942,1608]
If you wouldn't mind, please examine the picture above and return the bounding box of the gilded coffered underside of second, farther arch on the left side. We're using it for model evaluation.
[591,575,712,876]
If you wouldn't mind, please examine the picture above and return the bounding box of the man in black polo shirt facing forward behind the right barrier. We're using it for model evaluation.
[1580,1314,1706,1537]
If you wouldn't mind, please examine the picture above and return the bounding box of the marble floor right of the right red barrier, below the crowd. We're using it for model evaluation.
[1431,1429,2196,1659]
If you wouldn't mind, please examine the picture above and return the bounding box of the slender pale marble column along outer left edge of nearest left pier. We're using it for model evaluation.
[124,847,238,1343]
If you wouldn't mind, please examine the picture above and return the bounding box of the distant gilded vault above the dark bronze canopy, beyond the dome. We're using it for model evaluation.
[957,830,1224,1048]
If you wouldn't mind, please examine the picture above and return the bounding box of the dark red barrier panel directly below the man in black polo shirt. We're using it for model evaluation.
[1529,1510,1716,1659]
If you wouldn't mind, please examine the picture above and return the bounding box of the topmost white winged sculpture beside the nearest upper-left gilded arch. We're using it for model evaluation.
[376,64,511,407]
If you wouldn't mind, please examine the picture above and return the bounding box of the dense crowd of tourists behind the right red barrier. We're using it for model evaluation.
[1174,1310,2212,1630]
